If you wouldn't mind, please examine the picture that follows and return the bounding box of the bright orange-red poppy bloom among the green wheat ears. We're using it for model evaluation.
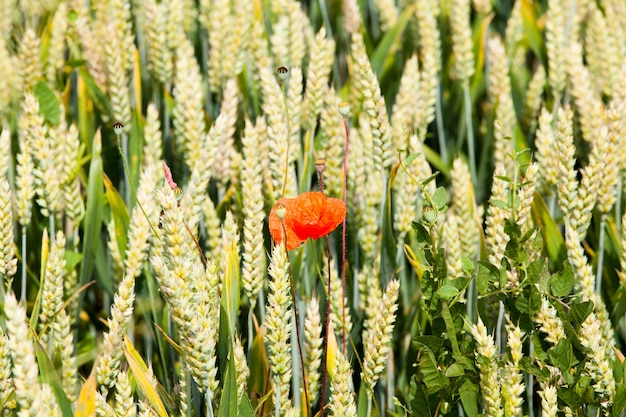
[270,191,347,250]
